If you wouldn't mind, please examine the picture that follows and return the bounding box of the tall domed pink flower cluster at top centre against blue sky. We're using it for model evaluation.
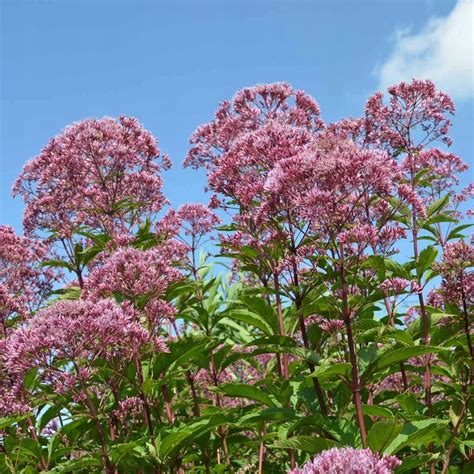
[185,83,323,218]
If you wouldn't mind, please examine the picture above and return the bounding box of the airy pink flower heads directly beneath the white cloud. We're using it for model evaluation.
[363,80,468,211]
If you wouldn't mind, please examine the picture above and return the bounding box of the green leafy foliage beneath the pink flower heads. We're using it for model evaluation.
[0,193,474,473]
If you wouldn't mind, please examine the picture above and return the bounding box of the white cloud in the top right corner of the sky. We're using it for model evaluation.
[377,0,474,99]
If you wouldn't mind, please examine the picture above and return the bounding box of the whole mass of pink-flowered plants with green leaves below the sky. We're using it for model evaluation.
[0,80,474,474]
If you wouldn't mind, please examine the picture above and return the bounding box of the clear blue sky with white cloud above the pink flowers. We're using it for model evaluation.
[0,0,474,230]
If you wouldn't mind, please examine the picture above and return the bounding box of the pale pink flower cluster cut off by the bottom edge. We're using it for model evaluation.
[290,448,401,474]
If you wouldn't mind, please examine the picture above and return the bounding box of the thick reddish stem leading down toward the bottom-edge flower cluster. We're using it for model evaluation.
[340,244,367,448]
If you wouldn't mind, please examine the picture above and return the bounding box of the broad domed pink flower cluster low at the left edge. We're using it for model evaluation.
[0,300,157,412]
